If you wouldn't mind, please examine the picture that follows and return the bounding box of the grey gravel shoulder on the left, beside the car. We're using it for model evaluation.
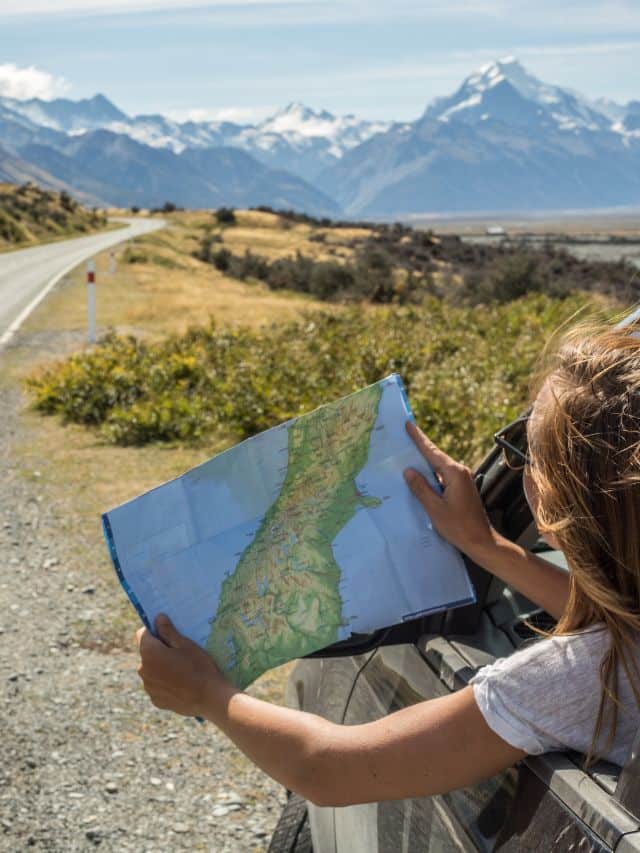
[0,341,285,853]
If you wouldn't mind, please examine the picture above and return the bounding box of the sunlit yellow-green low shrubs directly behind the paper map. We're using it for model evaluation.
[28,294,596,461]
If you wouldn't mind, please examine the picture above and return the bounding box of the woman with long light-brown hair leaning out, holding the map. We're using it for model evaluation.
[137,320,640,806]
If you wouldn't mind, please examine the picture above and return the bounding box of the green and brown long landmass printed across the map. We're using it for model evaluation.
[206,384,383,688]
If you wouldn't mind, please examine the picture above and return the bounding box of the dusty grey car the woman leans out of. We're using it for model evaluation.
[269,404,640,853]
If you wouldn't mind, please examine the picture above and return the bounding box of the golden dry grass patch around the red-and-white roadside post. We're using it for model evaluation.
[24,213,336,337]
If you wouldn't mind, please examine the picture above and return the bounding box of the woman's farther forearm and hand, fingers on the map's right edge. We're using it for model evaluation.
[405,422,569,619]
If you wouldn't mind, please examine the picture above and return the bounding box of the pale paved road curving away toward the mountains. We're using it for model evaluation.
[0,219,166,349]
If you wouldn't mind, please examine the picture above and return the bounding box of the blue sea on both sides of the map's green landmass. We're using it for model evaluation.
[103,374,474,672]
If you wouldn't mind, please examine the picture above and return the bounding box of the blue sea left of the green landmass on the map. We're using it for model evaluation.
[105,424,288,645]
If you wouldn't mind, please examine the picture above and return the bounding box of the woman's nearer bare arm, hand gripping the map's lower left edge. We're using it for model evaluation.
[138,617,526,806]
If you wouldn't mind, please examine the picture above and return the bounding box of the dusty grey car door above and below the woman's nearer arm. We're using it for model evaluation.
[334,564,640,853]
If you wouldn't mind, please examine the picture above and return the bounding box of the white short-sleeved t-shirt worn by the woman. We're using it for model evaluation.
[471,626,640,765]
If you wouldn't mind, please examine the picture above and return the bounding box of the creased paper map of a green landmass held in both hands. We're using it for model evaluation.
[103,375,474,687]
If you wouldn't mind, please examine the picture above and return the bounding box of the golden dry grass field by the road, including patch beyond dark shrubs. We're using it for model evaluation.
[24,211,350,336]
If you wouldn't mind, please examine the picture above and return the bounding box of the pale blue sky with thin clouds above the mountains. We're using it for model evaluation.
[0,0,640,119]
